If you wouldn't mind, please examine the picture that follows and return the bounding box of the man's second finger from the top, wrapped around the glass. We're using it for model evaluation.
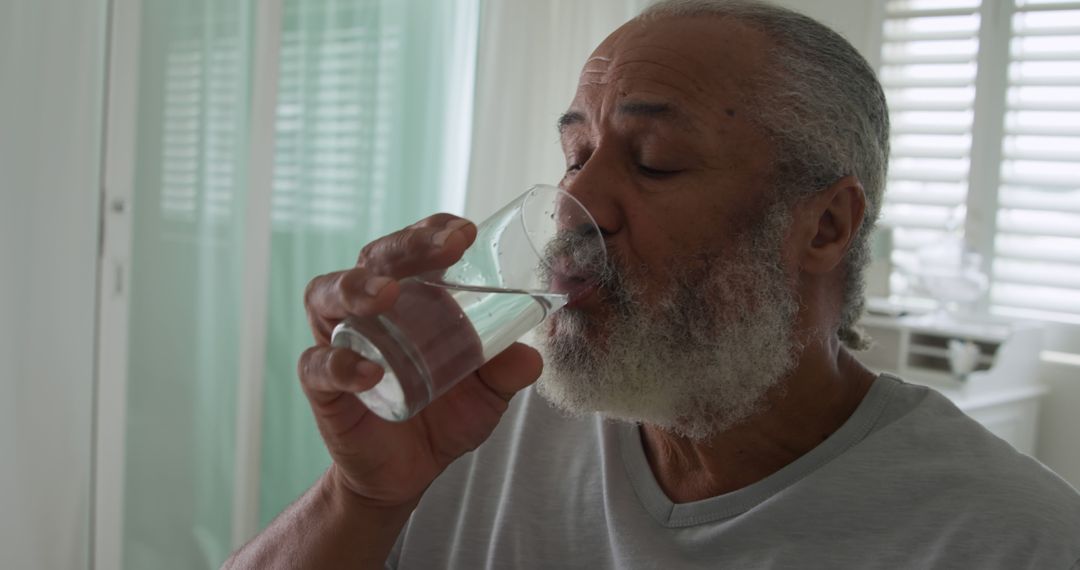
[303,268,401,343]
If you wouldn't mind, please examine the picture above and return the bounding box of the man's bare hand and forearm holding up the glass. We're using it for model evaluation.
[225,214,542,570]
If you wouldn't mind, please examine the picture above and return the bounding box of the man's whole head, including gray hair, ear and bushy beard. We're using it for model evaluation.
[538,0,887,438]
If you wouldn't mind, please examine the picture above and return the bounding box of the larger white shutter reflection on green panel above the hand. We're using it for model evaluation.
[272,0,400,230]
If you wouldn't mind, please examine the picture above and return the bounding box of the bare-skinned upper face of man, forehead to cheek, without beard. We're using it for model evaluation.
[561,18,772,304]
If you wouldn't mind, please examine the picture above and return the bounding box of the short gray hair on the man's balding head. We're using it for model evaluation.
[638,0,889,350]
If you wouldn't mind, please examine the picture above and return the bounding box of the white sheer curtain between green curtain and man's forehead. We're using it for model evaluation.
[465,0,650,219]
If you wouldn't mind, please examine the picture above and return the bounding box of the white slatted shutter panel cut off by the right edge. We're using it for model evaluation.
[990,0,1080,321]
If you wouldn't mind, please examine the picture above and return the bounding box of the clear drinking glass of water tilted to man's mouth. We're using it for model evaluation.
[330,185,606,421]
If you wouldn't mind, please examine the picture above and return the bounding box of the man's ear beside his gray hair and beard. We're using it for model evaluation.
[794,176,866,273]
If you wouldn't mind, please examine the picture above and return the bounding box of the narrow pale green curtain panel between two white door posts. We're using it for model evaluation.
[123,0,254,570]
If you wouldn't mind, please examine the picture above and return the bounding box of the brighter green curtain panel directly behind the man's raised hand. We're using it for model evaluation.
[260,0,478,525]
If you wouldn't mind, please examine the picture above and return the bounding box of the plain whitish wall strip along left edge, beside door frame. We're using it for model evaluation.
[0,0,106,570]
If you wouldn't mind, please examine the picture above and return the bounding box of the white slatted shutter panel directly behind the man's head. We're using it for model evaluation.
[880,0,980,276]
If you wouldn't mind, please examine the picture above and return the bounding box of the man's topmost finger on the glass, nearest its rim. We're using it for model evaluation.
[357,214,476,279]
